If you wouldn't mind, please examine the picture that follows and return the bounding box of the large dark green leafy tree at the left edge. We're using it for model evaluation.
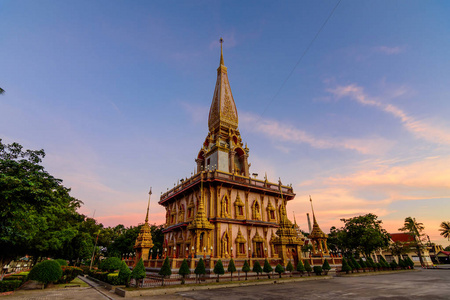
[0,139,82,271]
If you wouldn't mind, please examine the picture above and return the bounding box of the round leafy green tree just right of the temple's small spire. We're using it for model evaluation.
[336,214,390,256]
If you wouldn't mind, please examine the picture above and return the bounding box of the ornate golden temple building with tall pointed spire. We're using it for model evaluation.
[159,40,303,265]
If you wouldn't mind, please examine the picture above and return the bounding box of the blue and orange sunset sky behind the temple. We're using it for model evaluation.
[0,0,450,245]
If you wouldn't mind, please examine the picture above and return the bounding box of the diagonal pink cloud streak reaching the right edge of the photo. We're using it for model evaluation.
[328,84,450,145]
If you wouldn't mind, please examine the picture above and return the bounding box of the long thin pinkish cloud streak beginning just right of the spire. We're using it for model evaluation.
[240,112,392,154]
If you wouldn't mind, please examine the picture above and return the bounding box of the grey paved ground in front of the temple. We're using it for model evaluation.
[2,270,450,300]
